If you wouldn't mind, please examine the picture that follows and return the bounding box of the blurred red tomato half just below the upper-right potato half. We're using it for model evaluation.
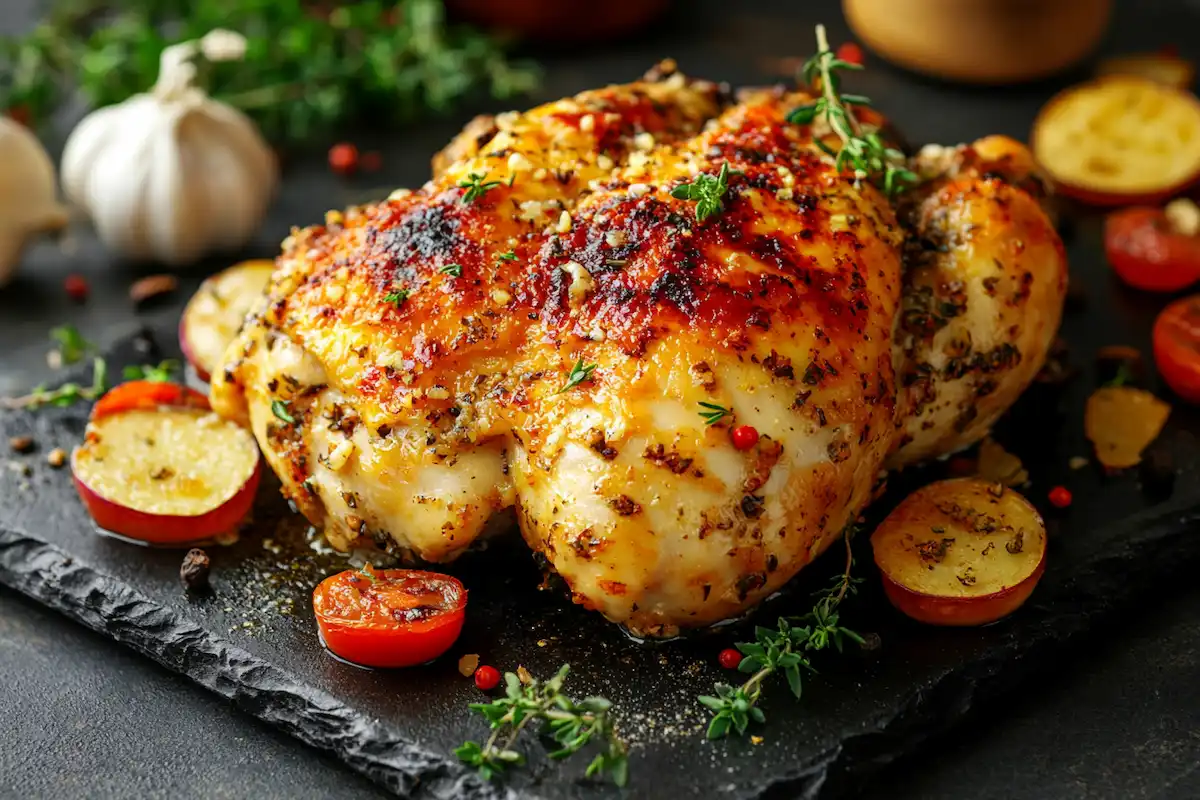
[1104,207,1200,291]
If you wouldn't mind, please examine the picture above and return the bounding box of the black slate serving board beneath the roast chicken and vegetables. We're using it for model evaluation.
[0,218,1200,798]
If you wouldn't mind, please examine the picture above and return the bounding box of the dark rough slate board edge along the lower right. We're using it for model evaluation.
[751,499,1200,800]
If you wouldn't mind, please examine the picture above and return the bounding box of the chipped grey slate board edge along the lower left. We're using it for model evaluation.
[0,528,516,800]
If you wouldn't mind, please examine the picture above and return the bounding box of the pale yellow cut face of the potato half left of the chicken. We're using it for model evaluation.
[73,409,258,517]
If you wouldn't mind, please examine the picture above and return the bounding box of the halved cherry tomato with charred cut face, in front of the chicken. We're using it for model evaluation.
[312,565,467,667]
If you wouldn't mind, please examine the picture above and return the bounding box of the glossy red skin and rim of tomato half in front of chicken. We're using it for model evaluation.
[312,570,467,669]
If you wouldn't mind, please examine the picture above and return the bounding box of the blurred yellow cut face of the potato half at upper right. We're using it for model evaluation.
[1032,77,1200,194]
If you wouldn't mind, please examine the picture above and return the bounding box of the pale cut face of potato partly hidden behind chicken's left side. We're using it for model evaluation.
[184,261,275,372]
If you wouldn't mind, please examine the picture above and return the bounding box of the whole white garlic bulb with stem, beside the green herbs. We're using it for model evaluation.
[62,30,278,264]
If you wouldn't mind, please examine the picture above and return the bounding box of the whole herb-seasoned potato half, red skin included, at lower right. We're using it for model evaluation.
[871,479,1046,625]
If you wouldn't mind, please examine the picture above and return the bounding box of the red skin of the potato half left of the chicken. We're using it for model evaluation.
[71,456,263,547]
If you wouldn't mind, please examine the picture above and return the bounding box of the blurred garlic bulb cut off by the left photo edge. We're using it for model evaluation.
[0,116,67,287]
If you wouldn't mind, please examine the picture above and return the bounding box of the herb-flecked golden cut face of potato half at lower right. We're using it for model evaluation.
[871,479,1046,599]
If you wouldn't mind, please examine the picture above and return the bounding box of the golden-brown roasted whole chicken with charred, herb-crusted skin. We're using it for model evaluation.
[212,65,1066,636]
